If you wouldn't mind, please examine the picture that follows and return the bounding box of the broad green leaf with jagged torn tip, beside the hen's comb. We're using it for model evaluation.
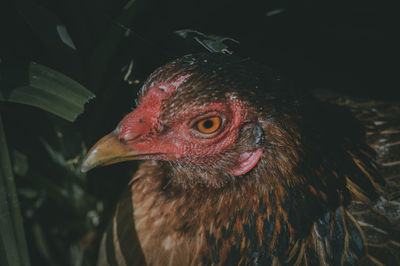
[0,62,95,122]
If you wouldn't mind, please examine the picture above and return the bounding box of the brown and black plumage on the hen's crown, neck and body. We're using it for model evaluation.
[95,54,400,265]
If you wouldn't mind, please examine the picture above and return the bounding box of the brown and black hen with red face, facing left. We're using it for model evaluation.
[82,54,400,266]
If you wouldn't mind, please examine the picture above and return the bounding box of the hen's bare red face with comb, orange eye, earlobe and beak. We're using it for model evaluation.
[82,75,263,179]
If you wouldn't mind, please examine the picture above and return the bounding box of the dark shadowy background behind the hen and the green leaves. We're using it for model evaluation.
[0,0,400,265]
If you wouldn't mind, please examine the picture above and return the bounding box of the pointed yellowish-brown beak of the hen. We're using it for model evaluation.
[81,132,143,172]
